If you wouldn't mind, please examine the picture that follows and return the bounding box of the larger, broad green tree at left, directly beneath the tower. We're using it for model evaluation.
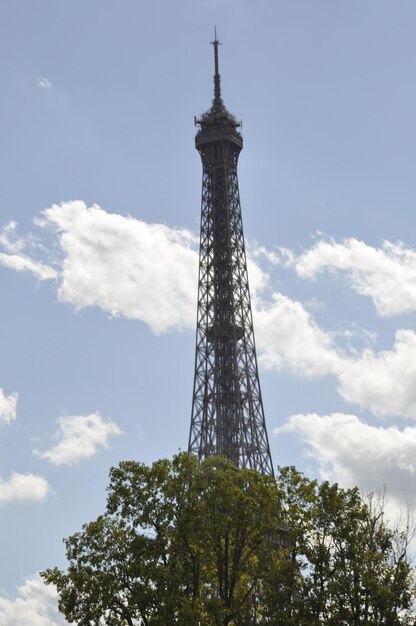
[42,454,281,626]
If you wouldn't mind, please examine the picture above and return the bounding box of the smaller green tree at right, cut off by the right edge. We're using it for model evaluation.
[270,468,416,626]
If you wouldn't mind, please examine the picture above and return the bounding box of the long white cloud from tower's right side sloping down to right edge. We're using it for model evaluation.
[250,293,416,418]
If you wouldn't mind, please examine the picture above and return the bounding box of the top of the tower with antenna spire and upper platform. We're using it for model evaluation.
[195,33,243,151]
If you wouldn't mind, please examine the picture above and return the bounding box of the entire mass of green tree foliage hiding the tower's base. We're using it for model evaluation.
[42,453,415,626]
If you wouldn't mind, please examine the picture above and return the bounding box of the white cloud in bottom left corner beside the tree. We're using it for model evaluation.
[0,574,68,626]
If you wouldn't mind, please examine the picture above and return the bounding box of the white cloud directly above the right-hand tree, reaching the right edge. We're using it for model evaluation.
[274,413,416,502]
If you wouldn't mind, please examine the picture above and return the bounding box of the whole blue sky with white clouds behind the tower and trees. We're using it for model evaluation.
[0,0,416,626]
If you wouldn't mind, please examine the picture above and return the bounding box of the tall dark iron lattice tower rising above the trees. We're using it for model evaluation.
[188,37,273,474]
